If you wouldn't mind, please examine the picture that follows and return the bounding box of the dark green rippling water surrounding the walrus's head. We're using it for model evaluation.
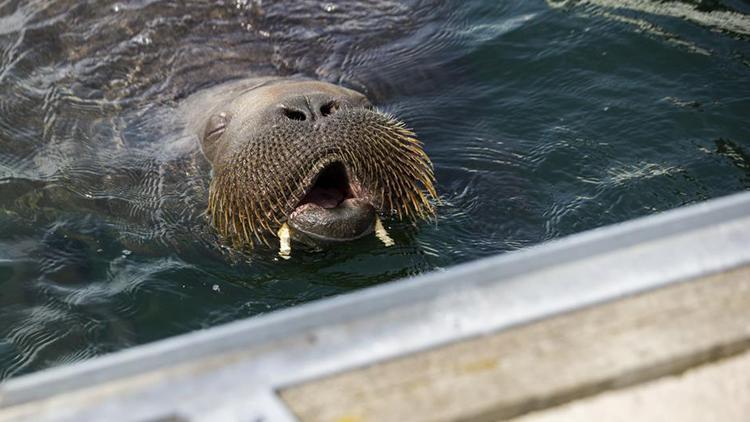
[0,0,750,379]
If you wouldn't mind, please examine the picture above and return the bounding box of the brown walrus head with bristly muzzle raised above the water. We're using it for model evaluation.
[201,79,436,246]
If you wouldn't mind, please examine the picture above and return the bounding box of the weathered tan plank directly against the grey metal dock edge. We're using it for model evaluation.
[279,267,750,421]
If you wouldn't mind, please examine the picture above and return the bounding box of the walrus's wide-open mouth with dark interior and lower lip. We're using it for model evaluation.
[289,161,376,243]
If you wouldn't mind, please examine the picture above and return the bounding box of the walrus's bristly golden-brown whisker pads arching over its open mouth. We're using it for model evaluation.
[209,108,437,249]
